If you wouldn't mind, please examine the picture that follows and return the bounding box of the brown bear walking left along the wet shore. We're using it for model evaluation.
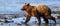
[21,3,56,23]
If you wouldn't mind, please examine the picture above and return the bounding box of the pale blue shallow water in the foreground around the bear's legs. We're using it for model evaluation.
[0,17,60,26]
